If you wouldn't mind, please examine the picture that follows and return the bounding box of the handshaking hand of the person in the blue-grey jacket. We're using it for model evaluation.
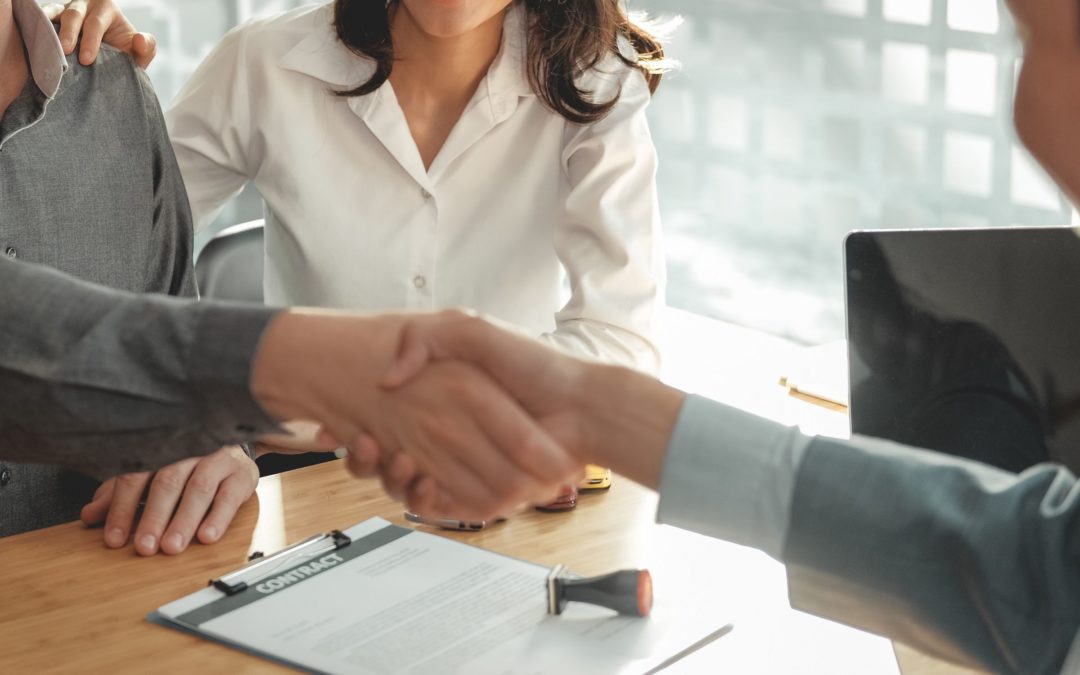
[375,311,685,514]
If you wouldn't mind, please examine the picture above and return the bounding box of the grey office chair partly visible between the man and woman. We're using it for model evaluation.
[195,220,334,476]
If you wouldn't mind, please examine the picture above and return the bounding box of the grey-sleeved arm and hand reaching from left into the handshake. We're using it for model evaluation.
[0,259,581,519]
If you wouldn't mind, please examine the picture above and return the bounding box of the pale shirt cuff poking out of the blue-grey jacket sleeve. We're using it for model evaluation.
[657,395,810,558]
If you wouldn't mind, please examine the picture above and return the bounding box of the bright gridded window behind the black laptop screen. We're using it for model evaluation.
[631,0,1071,343]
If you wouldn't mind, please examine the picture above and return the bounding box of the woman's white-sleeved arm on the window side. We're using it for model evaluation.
[543,69,664,372]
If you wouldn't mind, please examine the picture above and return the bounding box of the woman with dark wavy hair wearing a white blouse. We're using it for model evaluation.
[155,0,663,369]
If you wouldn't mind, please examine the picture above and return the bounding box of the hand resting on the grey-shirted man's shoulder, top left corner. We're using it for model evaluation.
[43,0,158,69]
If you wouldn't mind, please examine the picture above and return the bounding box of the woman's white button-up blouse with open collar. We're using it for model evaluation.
[166,3,663,369]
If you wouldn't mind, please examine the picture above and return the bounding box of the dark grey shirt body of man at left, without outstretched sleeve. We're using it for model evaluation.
[0,31,195,536]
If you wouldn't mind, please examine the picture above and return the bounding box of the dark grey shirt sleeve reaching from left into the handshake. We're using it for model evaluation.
[0,254,276,476]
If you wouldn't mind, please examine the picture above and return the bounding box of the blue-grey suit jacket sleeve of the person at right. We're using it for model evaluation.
[783,438,1080,674]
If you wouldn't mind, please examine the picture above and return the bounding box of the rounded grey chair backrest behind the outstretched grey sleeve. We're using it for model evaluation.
[195,220,264,302]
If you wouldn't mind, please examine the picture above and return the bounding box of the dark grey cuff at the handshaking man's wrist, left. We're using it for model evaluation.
[188,301,282,445]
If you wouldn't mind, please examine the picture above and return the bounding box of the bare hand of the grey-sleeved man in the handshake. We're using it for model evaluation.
[252,310,584,519]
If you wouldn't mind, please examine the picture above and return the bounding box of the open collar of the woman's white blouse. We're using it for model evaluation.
[276,0,532,117]
